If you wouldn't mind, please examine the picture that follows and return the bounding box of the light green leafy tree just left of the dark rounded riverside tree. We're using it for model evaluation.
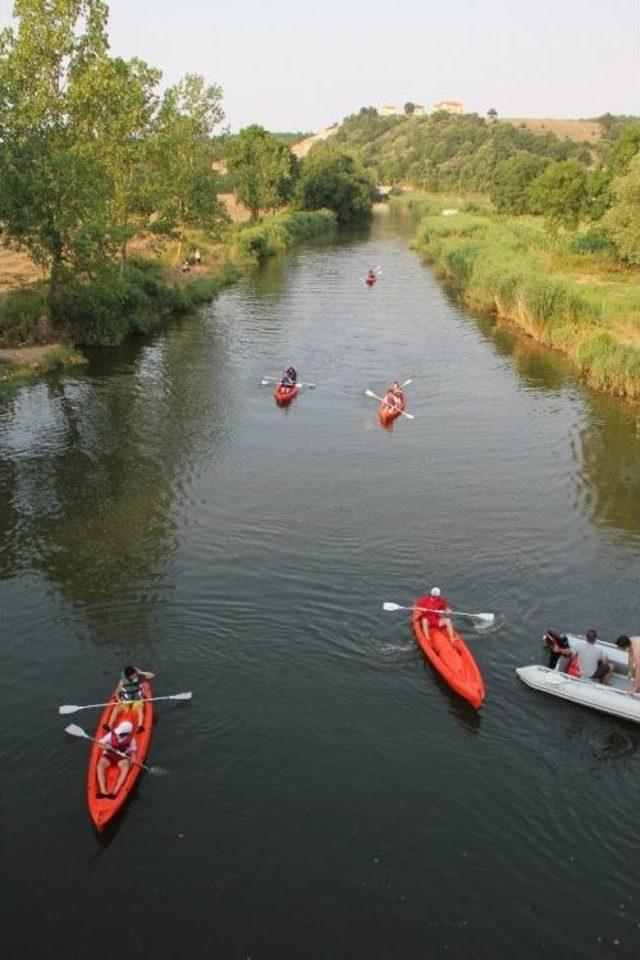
[227,124,297,220]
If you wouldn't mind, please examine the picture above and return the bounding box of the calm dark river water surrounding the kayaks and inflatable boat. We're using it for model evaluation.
[0,216,640,960]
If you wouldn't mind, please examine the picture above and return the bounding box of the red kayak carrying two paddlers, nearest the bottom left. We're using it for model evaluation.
[87,680,153,833]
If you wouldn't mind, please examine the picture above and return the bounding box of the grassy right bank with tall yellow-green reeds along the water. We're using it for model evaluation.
[396,197,640,399]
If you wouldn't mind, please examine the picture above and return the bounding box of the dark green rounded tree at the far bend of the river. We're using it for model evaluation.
[296,142,374,223]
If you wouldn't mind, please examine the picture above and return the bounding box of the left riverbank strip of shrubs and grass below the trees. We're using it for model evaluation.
[0,210,336,385]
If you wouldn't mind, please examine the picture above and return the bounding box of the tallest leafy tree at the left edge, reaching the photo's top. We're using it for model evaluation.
[0,0,114,301]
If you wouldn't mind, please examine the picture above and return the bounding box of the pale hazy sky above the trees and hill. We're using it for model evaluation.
[0,0,640,131]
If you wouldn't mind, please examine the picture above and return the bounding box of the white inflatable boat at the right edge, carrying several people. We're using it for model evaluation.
[516,634,640,723]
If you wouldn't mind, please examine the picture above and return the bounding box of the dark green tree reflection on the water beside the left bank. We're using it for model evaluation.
[0,318,227,640]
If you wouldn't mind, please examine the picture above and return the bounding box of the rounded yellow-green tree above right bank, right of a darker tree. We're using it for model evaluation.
[529,160,588,228]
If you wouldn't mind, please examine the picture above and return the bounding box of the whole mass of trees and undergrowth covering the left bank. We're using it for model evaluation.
[0,0,334,356]
